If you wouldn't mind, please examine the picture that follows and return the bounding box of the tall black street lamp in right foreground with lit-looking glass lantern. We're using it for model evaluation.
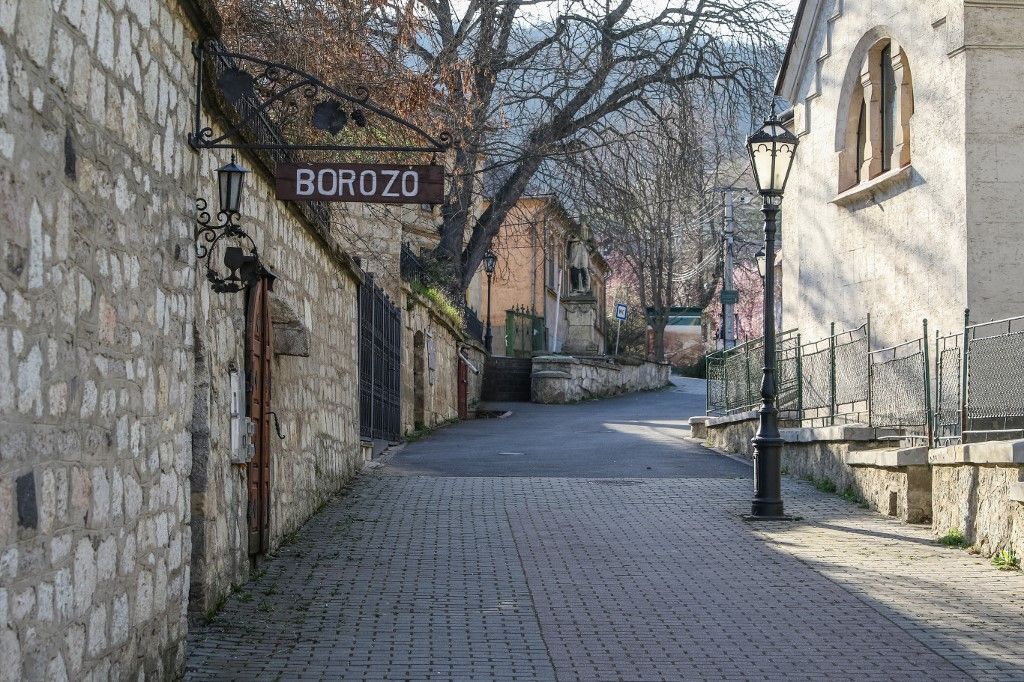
[746,112,799,520]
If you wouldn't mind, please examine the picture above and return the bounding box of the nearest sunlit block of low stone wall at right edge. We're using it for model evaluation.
[928,440,1024,557]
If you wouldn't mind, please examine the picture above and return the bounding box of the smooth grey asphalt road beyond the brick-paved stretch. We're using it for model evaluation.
[385,379,751,478]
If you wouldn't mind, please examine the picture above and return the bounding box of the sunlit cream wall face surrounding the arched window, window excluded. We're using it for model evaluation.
[782,0,966,346]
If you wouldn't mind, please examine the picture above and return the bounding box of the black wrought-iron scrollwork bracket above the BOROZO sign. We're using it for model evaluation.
[188,40,452,154]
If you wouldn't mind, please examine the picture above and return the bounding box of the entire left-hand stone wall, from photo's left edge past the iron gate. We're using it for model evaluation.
[0,0,479,680]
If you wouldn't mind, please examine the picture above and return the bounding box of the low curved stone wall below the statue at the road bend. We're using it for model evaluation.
[530,355,672,404]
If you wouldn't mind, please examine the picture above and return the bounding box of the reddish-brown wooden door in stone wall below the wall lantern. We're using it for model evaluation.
[246,278,273,554]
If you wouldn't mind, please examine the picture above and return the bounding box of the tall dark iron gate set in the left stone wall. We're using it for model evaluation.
[359,274,401,440]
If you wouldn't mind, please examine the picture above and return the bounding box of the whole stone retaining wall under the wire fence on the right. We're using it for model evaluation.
[690,413,1024,544]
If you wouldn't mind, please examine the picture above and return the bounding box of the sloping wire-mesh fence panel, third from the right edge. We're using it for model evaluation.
[868,321,932,442]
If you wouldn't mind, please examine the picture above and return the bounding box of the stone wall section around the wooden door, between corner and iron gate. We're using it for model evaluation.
[190,146,361,613]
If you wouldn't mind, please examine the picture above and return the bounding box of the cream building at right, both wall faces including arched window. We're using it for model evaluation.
[777,0,1024,345]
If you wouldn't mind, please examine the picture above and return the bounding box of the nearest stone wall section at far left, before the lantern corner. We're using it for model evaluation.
[0,0,209,680]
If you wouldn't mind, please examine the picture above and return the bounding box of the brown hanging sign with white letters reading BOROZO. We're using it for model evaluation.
[274,163,444,204]
